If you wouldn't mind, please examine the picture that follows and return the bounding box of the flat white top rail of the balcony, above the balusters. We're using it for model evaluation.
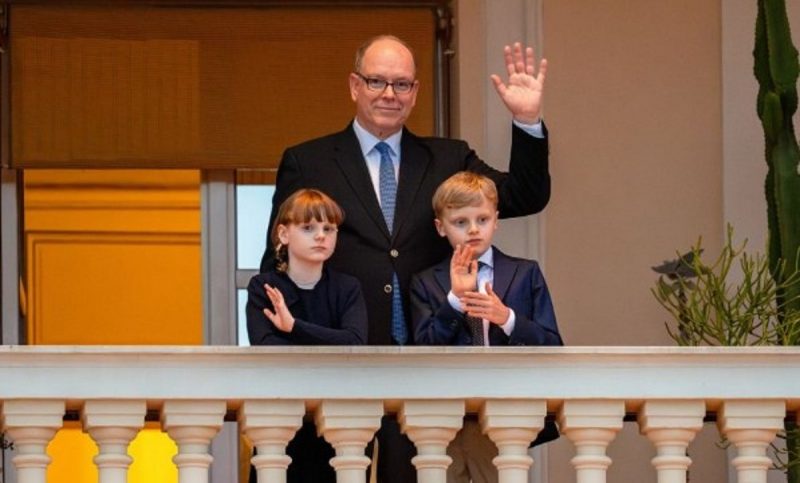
[0,346,800,410]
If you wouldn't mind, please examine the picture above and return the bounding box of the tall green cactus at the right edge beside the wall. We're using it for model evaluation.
[753,0,800,483]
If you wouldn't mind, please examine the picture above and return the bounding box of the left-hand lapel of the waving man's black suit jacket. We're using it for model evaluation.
[334,123,397,239]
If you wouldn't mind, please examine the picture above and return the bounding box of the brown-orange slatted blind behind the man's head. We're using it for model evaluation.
[10,3,435,169]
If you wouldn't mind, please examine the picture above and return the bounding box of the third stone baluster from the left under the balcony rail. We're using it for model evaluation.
[161,400,226,483]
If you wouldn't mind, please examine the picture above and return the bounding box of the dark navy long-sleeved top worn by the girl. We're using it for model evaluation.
[245,268,367,345]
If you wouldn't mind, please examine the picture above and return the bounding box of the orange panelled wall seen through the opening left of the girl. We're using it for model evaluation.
[25,170,203,483]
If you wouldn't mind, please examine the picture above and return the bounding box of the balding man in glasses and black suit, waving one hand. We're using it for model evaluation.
[261,36,550,483]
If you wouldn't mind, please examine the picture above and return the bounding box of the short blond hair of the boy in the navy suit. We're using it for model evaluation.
[432,171,497,218]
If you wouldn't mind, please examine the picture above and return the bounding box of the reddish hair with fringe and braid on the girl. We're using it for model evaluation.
[271,188,344,271]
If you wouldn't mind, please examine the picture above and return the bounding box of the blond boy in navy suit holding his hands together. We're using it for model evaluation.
[411,171,563,483]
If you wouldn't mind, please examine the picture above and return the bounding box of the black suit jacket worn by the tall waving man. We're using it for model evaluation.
[261,124,550,345]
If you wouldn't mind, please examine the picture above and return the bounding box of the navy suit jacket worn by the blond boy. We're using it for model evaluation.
[411,247,564,446]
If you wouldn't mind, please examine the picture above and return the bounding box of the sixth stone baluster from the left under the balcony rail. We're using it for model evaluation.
[397,400,464,483]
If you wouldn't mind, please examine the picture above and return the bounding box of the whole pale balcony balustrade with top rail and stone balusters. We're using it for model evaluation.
[0,346,800,483]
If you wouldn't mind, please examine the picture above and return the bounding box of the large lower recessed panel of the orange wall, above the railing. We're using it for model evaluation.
[28,233,202,344]
